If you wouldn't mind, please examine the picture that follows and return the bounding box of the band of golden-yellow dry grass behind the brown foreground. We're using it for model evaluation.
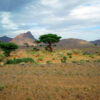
[9,48,100,64]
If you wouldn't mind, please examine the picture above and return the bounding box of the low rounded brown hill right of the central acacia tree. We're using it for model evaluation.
[57,38,93,48]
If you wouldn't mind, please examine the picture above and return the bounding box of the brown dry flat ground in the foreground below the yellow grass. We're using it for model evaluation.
[0,63,100,100]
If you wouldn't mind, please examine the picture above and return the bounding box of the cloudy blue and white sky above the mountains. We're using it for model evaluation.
[0,0,100,41]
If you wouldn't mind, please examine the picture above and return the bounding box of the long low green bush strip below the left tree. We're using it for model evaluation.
[5,58,34,64]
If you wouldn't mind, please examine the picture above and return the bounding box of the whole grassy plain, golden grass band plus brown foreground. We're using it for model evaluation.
[0,48,100,100]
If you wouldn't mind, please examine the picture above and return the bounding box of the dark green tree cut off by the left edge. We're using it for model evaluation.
[0,42,18,57]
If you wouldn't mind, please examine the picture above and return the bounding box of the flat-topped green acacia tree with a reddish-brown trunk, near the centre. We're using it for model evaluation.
[38,34,61,52]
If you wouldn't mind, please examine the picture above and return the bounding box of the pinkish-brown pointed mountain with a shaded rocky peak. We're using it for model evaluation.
[11,32,36,46]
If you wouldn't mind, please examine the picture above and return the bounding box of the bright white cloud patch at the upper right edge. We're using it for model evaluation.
[70,5,100,20]
